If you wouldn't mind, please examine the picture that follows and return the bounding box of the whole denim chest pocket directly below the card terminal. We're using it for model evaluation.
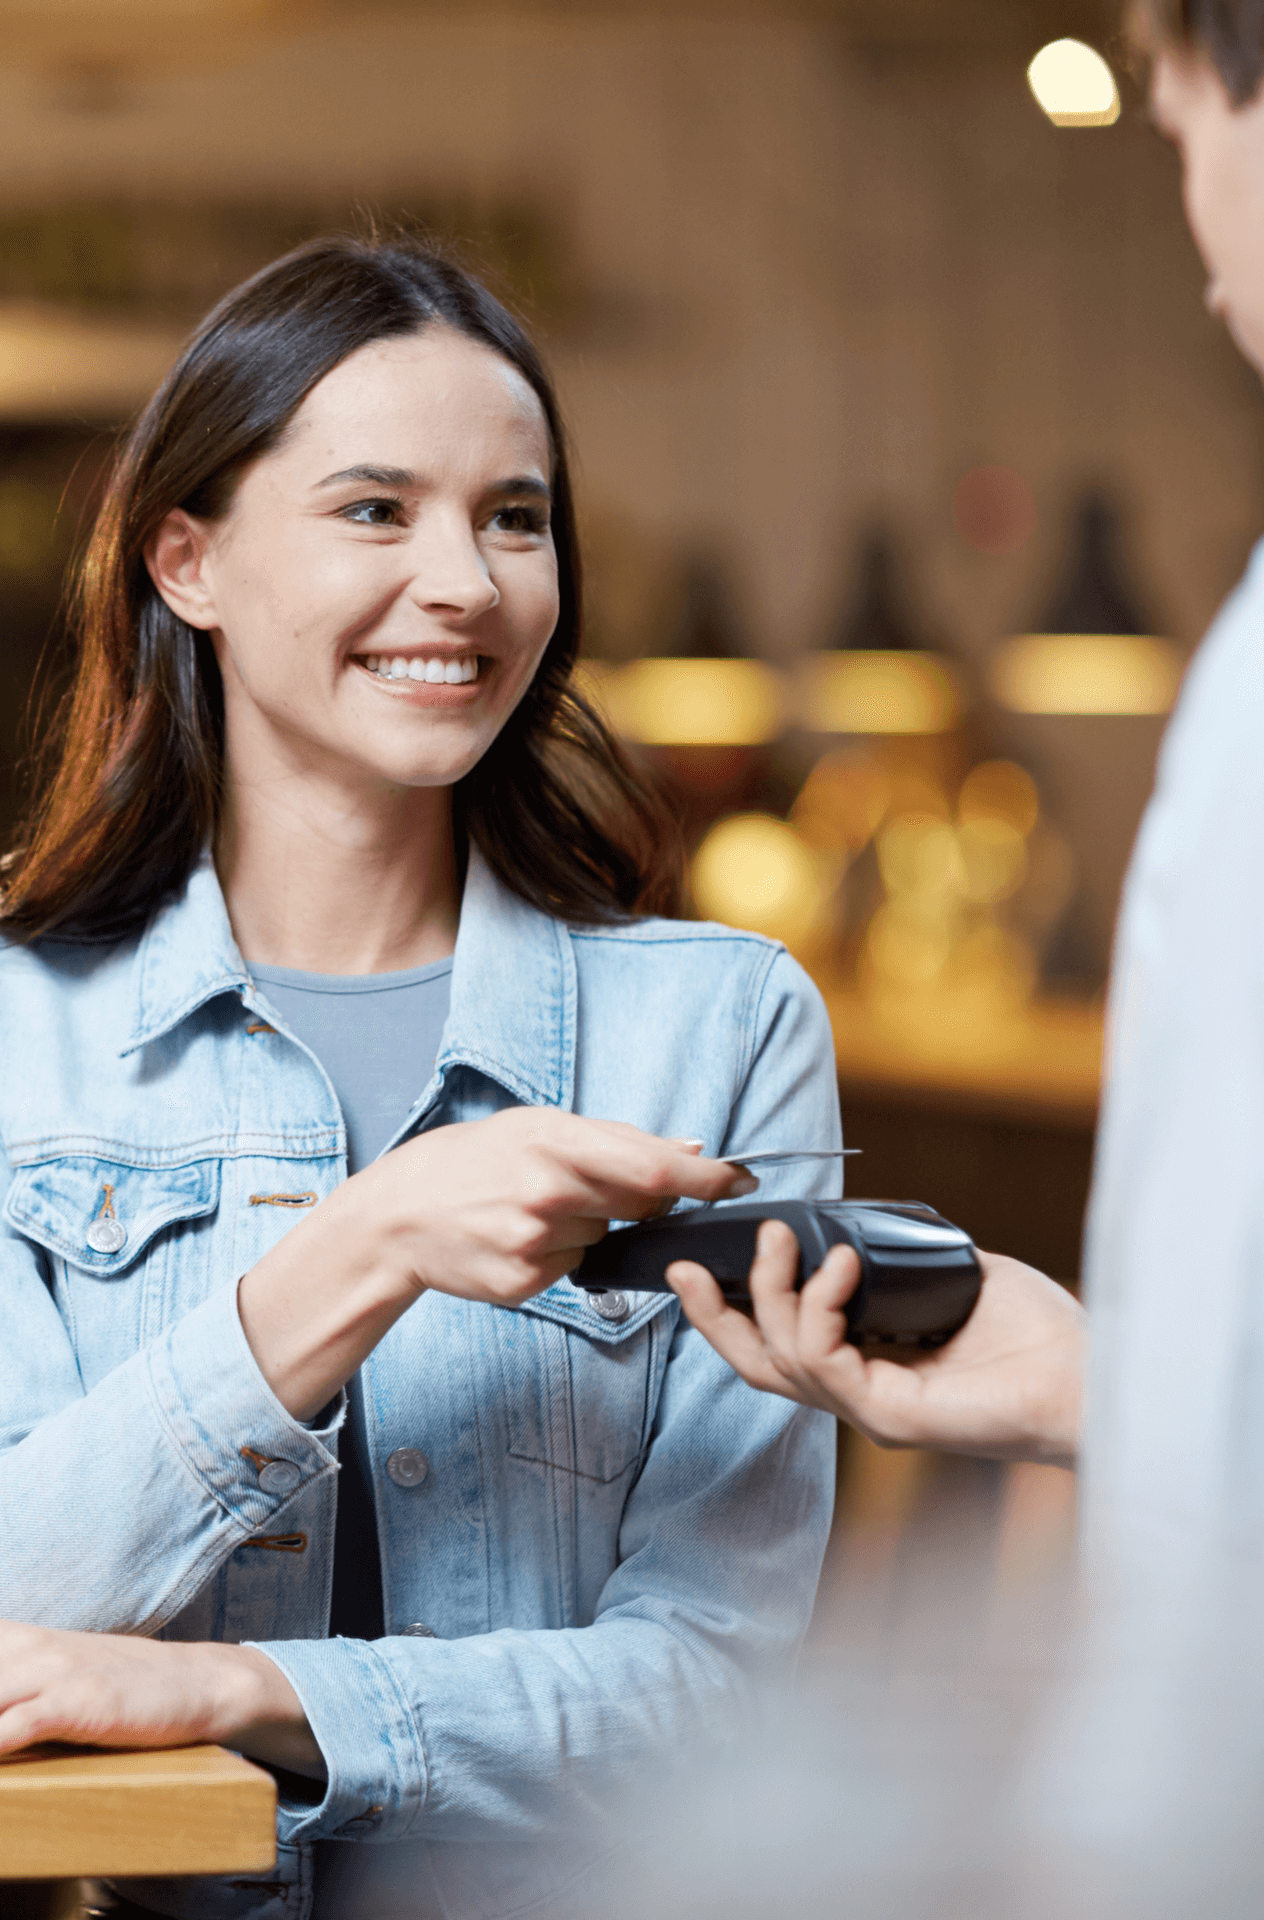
[496,1281,674,1486]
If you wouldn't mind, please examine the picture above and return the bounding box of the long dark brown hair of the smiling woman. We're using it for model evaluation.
[0,236,678,941]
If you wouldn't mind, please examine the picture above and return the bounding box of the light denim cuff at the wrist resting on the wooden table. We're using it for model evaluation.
[248,1640,428,1843]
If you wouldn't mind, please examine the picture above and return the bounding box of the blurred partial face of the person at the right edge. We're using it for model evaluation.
[1151,48,1264,372]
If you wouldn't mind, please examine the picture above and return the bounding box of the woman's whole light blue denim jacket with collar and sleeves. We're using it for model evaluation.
[0,854,839,1920]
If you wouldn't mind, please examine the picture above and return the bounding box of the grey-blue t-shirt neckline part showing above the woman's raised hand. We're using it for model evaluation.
[250,960,451,1173]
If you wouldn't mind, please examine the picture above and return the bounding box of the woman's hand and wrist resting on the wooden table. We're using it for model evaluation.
[0,1620,323,1778]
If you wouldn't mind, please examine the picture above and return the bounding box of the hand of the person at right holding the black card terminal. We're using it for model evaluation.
[667,1219,1085,1467]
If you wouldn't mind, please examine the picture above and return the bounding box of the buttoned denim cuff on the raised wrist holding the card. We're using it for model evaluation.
[148,1283,346,1532]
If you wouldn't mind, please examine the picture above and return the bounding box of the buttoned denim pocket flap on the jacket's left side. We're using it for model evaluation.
[4,1156,219,1281]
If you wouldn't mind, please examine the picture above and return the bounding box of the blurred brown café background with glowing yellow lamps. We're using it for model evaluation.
[0,0,1264,1640]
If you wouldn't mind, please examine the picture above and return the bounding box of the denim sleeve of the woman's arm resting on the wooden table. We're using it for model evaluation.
[247,952,839,1841]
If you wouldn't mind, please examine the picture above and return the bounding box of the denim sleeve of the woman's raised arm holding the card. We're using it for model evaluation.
[0,1128,342,1632]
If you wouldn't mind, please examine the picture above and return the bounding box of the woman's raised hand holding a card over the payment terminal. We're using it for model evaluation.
[238,1106,755,1421]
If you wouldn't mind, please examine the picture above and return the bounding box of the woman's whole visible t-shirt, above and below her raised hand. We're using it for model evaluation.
[250,960,451,1640]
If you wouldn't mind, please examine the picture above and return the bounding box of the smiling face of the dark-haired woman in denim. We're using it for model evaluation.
[146,326,557,791]
